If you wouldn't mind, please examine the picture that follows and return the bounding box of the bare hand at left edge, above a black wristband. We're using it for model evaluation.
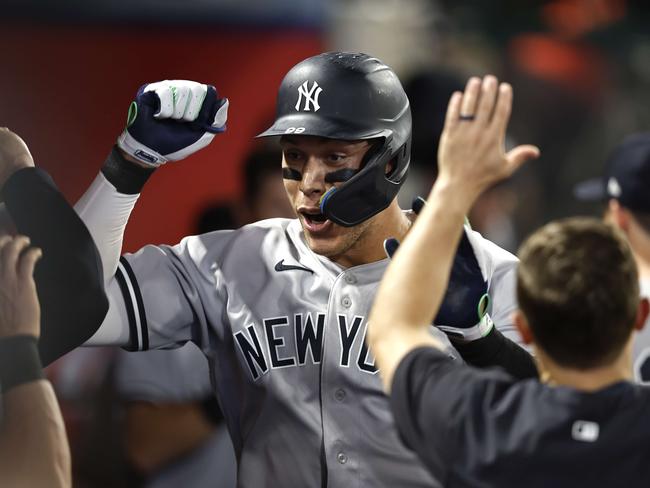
[0,236,41,338]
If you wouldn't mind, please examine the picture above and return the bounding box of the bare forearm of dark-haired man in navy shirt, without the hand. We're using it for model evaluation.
[369,182,468,387]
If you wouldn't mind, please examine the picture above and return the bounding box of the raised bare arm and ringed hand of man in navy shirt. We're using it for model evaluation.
[369,76,539,390]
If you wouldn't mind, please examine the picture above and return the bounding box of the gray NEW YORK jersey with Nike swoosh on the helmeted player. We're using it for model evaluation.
[111,219,516,488]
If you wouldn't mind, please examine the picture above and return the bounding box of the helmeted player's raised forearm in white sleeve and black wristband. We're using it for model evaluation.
[74,148,153,283]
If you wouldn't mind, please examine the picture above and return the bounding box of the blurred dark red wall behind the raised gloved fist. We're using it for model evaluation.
[0,2,322,250]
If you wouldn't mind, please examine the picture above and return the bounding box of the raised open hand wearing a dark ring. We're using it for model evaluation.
[438,76,539,203]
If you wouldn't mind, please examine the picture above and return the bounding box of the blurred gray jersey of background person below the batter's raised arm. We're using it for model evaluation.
[115,343,237,488]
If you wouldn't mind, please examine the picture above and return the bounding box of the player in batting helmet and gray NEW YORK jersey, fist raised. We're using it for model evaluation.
[77,53,536,487]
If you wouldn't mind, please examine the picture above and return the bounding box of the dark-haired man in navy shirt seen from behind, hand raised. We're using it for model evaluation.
[368,81,650,488]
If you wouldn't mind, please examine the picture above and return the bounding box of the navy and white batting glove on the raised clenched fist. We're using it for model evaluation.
[117,80,228,168]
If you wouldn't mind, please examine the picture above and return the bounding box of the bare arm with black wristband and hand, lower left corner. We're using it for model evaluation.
[0,236,71,487]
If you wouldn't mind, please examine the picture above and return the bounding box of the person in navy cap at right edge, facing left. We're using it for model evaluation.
[575,132,650,384]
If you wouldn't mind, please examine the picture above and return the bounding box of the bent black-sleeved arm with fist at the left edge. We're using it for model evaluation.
[0,128,108,365]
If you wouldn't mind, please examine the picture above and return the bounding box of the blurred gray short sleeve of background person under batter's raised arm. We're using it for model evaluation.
[115,343,212,403]
